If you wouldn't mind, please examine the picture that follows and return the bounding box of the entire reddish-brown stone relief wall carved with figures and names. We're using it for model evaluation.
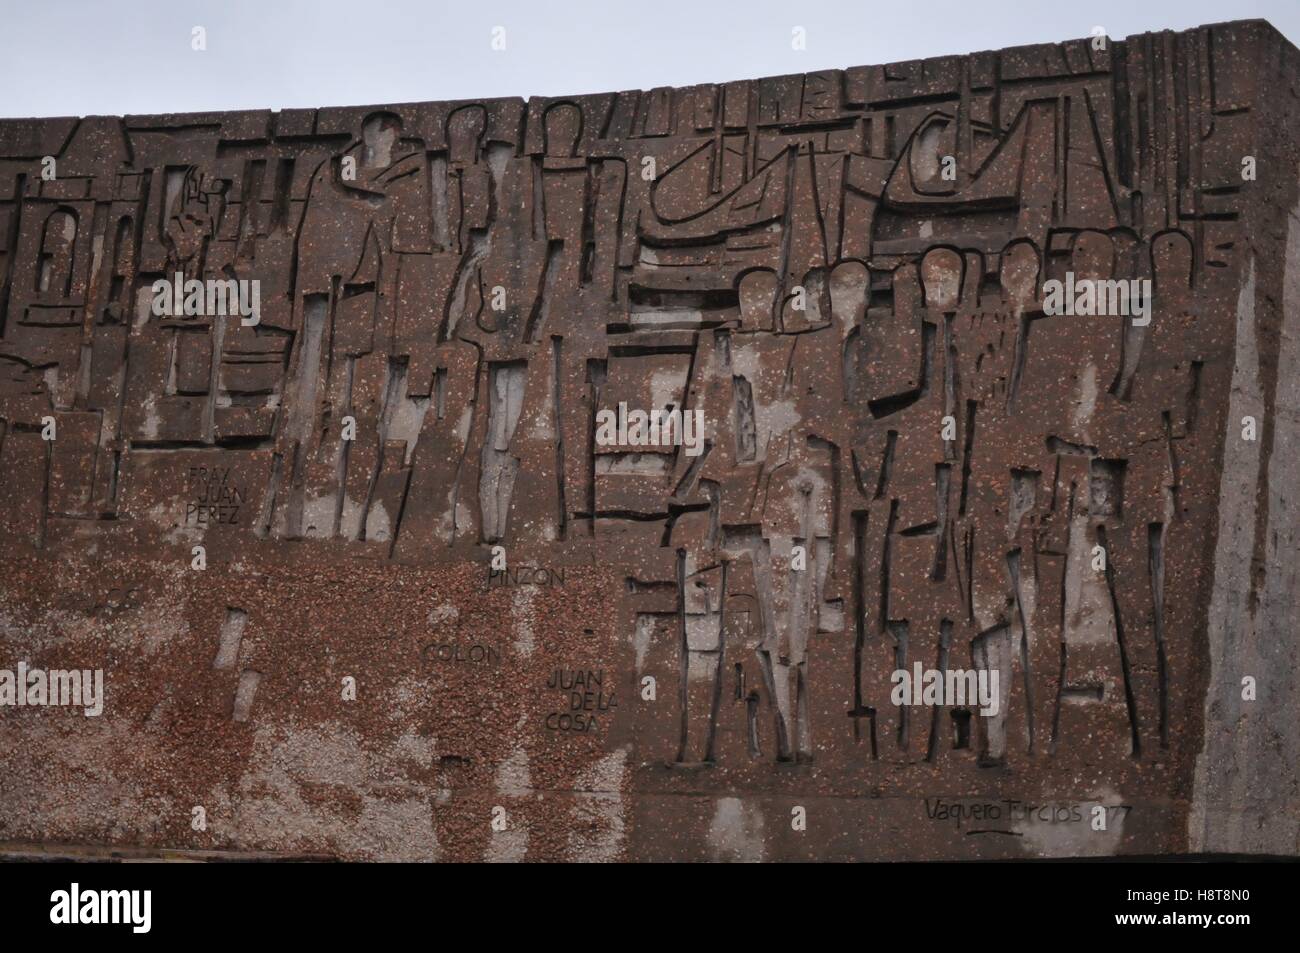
[0,22,1300,861]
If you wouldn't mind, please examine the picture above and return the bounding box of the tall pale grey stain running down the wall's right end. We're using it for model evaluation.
[1188,180,1300,854]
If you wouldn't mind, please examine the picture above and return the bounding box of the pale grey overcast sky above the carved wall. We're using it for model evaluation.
[0,0,1300,117]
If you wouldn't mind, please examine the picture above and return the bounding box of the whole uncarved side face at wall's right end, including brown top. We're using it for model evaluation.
[1190,35,1300,854]
